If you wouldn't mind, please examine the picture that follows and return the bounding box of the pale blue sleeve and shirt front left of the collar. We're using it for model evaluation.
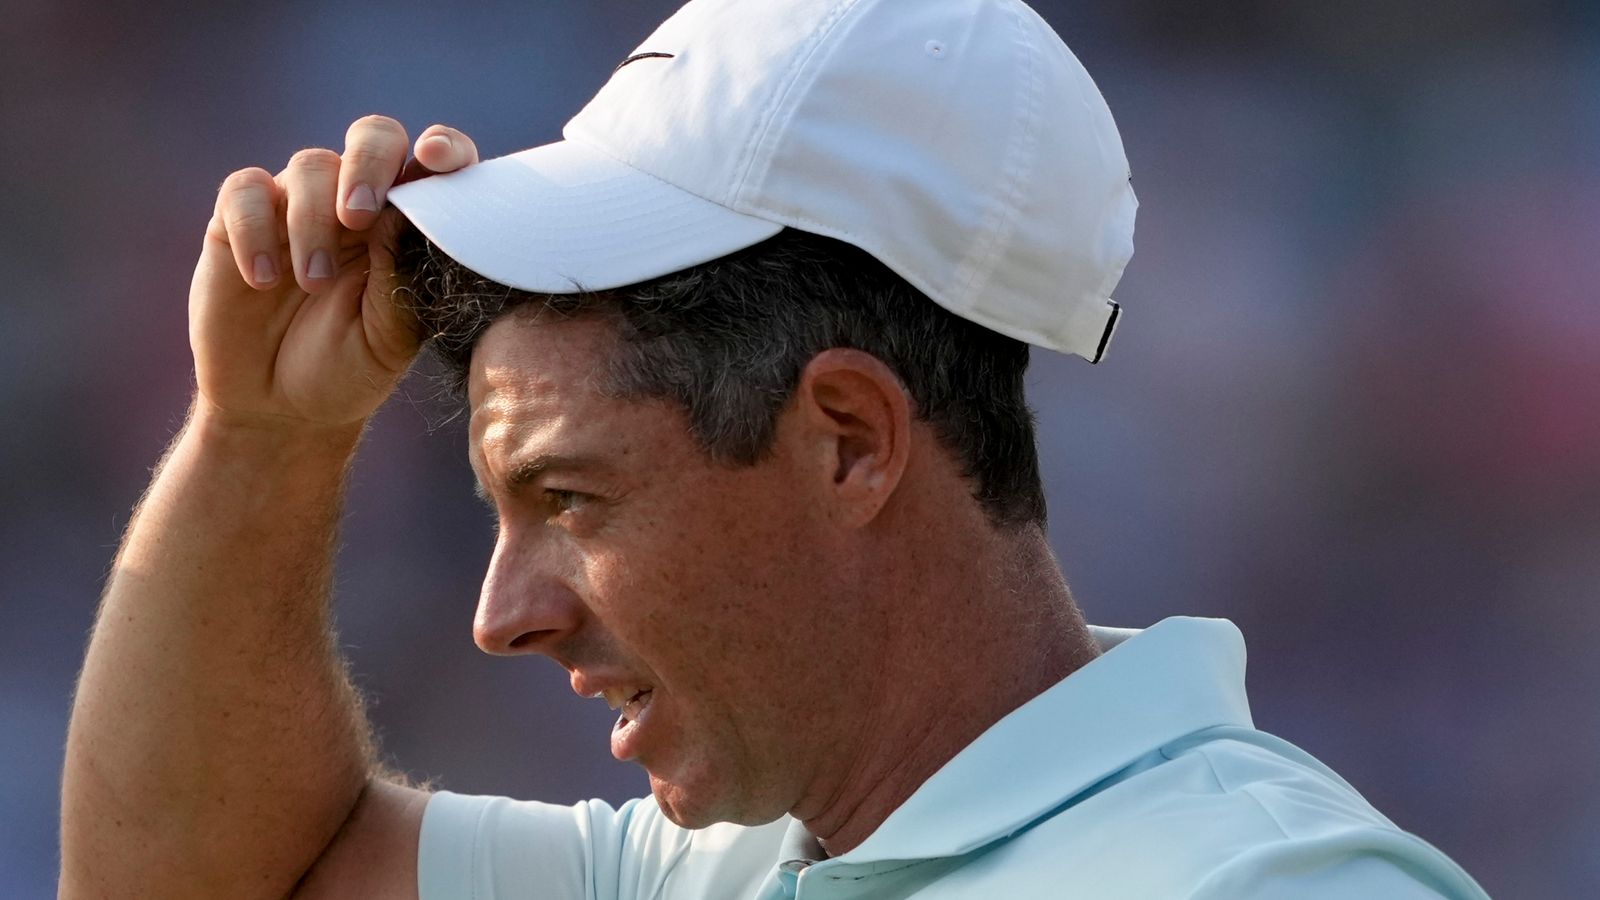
[416,791,782,900]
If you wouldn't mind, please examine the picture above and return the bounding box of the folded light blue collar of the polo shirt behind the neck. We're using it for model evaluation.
[832,617,1253,863]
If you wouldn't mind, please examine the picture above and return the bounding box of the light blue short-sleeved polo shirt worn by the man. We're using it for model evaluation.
[418,618,1486,900]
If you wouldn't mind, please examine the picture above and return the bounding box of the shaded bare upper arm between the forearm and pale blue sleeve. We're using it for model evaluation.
[293,778,429,900]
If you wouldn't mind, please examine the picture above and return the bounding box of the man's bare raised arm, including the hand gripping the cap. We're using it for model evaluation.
[59,117,477,898]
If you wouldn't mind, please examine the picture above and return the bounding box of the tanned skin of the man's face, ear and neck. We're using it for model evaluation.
[469,315,1093,854]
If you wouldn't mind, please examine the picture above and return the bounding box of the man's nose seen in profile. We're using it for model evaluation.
[472,530,584,657]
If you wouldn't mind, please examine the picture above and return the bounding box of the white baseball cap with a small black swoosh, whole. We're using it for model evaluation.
[389,0,1138,362]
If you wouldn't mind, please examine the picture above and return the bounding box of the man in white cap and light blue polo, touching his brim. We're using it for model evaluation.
[61,0,1482,900]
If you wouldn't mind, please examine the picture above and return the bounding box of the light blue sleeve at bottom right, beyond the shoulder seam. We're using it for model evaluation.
[1189,830,1488,900]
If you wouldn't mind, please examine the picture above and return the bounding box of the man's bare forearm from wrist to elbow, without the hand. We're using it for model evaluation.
[61,405,380,897]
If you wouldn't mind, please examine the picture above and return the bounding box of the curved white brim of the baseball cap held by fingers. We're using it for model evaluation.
[389,141,782,293]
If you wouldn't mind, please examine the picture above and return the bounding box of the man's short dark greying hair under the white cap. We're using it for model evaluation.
[395,224,1045,527]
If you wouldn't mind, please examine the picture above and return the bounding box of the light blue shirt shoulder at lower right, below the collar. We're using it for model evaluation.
[966,727,1485,900]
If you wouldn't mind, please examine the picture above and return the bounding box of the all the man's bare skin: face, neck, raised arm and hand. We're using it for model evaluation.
[59,117,1094,898]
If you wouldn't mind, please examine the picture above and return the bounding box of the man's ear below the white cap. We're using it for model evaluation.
[794,348,910,527]
